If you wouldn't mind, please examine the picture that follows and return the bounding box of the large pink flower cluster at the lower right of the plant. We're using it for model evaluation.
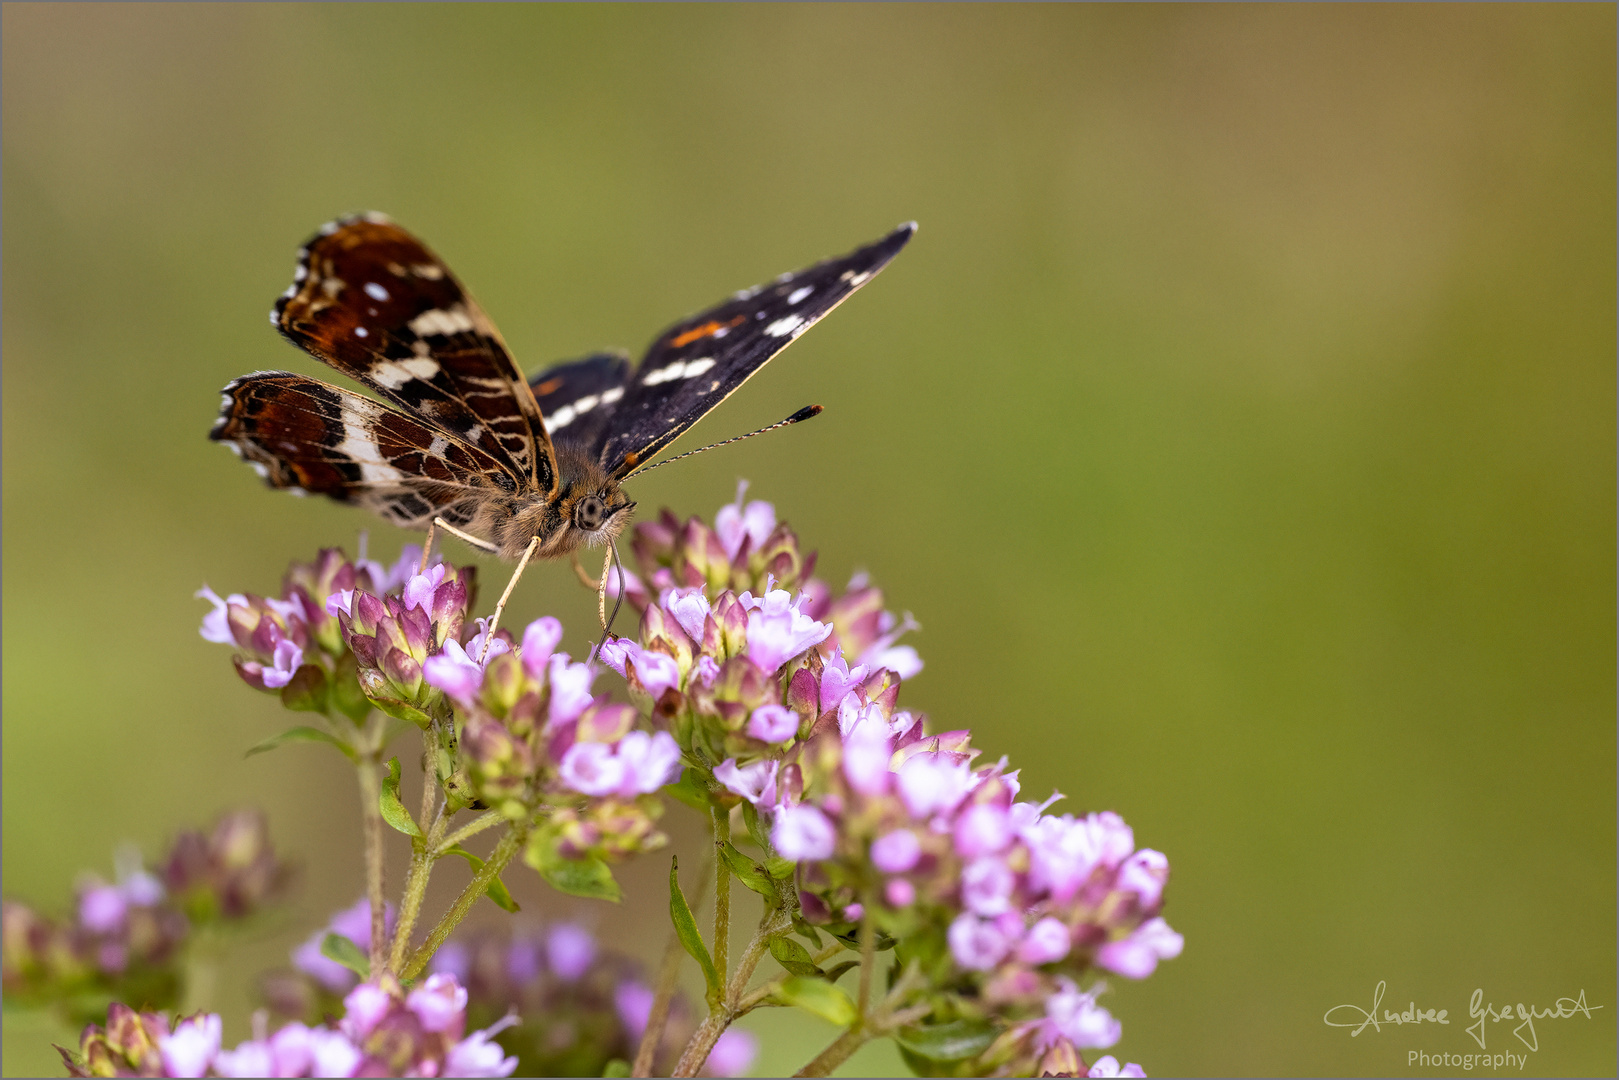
[738,693,1182,1075]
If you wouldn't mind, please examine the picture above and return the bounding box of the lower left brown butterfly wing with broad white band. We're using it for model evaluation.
[209,371,516,528]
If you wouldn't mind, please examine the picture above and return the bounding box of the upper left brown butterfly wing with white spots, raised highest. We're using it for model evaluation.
[270,214,557,497]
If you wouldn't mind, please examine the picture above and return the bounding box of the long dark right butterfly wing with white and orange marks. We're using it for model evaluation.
[599,222,916,478]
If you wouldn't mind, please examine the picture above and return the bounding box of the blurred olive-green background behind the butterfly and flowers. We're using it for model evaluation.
[0,3,1619,1075]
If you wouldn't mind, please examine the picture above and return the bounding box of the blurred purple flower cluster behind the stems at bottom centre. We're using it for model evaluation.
[431,923,758,1077]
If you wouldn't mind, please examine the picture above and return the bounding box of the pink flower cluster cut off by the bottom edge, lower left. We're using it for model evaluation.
[57,975,516,1077]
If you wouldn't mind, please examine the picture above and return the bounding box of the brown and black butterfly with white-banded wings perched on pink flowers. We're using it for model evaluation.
[209,214,916,562]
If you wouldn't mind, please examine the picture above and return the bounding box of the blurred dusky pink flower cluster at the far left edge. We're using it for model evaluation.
[0,811,290,1022]
